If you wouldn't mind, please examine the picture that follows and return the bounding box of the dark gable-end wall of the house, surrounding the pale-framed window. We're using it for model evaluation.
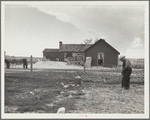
[85,41,118,67]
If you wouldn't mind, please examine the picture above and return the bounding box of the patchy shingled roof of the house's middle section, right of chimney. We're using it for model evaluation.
[59,44,92,52]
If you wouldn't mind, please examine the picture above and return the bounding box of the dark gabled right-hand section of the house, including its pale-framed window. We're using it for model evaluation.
[84,39,120,67]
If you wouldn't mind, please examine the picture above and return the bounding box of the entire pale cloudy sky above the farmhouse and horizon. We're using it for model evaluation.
[4,2,148,58]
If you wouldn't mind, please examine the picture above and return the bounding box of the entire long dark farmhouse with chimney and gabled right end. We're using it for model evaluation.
[43,39,120,67]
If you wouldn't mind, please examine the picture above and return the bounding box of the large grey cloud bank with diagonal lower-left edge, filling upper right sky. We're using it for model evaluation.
[27,4,144,45]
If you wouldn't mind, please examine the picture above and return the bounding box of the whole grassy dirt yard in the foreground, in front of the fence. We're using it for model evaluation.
[5,68,144,114]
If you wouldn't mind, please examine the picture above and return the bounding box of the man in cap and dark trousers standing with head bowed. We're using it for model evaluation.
[120,56,132,92]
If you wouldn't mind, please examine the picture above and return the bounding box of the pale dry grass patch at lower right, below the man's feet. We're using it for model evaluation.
[76,84,144,114]
